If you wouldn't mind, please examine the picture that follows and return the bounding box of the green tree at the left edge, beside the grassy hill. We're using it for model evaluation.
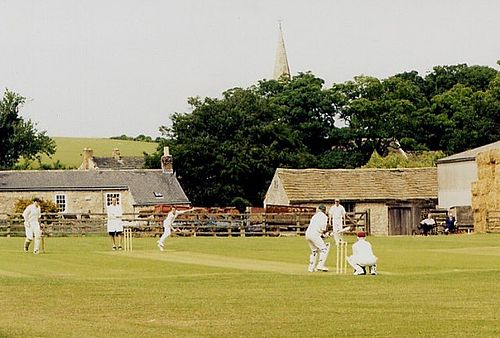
[0,90,55,169]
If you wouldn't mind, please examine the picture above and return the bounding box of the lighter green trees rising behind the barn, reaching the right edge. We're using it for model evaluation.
[333,65,500,154]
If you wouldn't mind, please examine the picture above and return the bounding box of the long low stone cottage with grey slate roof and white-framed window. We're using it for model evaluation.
[0,148,190,213]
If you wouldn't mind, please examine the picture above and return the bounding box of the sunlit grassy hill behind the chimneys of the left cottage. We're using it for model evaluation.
[26,137,157,168]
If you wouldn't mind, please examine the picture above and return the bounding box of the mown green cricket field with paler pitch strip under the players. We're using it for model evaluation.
[0,234,500,337]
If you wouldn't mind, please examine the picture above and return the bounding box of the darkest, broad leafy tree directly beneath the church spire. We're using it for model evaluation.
[146,74,342,206]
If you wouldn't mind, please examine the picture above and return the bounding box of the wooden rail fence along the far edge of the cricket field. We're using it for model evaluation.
[0,212,370,237]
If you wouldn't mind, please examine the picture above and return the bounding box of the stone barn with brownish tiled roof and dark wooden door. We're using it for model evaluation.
[264,168,437,235]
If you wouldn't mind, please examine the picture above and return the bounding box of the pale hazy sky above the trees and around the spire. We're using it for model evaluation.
[0,0,500,137]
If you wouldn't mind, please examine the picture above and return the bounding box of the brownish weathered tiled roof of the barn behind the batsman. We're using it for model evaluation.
[276,167,438,203]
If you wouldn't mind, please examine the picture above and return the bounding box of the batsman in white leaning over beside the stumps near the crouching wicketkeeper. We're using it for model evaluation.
[306,204,330,272]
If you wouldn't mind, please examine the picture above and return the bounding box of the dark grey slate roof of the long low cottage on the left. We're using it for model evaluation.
[0,169,189,205]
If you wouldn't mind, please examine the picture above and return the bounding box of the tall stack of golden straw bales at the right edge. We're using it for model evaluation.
[471,149,500,232]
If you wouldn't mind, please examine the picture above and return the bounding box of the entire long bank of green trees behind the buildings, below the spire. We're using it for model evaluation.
[146,65,500,208]
